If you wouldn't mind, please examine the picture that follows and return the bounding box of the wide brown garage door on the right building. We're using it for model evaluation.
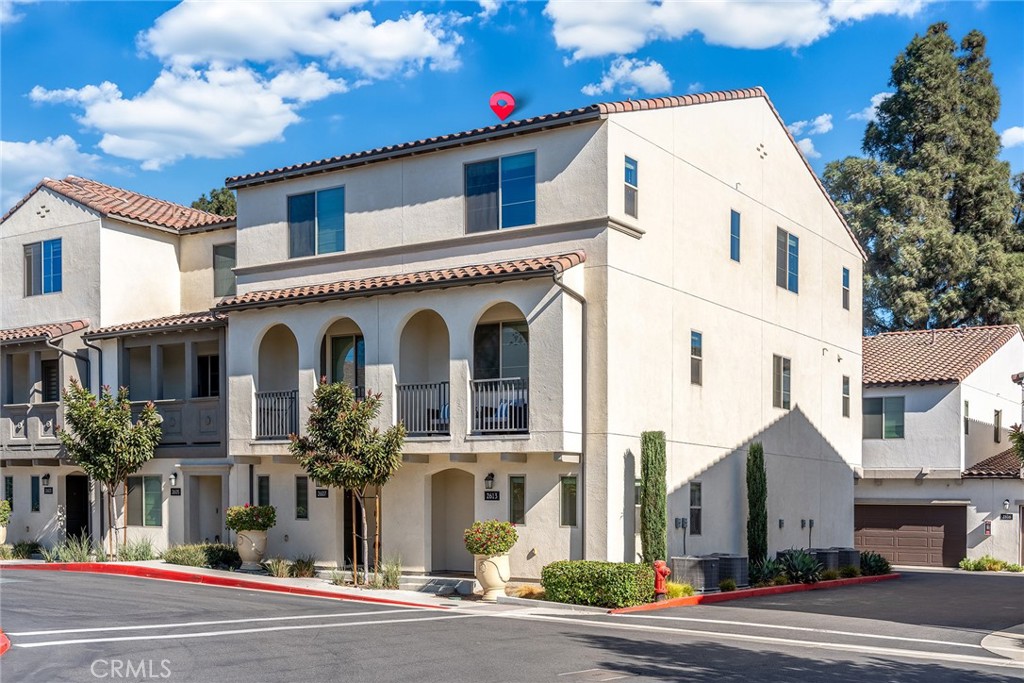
[853,505,967,567]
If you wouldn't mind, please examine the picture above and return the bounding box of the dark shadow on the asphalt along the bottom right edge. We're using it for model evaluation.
[569,634,1020,683]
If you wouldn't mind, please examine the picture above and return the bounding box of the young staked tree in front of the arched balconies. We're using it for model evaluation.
[291,379,406,583]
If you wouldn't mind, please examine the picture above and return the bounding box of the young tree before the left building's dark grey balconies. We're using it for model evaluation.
[57,379,162,555]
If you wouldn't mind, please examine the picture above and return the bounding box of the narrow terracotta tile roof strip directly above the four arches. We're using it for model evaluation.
[217,251,587,309]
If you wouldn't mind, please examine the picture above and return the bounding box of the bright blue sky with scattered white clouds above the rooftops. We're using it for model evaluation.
[0,0,1024,210]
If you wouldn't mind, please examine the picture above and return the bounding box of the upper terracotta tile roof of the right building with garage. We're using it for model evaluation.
[862,325,1021,385]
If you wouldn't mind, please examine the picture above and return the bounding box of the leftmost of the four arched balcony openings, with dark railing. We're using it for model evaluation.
[256,325,299,439]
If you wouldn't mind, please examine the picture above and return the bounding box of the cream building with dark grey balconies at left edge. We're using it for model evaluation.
[0,176,234,547]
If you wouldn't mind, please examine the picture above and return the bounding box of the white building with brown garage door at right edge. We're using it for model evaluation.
[856,325,1024,566]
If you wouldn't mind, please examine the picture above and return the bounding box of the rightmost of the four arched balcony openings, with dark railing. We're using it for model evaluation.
[470,303,529,433]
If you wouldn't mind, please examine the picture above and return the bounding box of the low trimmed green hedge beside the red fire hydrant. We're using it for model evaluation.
[541,560,654,607]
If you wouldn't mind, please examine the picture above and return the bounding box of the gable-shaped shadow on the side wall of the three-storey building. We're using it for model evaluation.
[668,405,854,556]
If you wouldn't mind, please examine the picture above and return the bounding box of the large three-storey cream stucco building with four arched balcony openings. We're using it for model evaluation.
[217,88,863,577]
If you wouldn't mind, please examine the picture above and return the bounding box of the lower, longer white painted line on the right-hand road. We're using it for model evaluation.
[503,612,1024,671]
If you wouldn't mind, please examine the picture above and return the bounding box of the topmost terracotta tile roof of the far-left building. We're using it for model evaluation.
[0,175,234,232]
